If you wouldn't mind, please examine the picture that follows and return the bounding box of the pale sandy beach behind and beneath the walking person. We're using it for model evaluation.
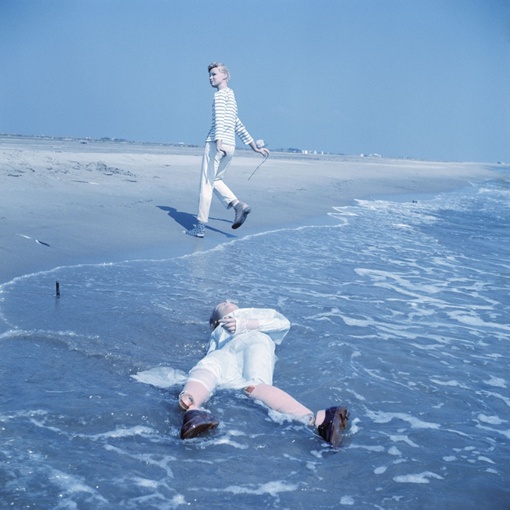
[0,136,496,283]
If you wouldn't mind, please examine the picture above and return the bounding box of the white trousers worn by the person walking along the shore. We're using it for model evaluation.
[197,142,237,223]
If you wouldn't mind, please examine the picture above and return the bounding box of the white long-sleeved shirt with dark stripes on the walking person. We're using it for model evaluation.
[206,87,253,147]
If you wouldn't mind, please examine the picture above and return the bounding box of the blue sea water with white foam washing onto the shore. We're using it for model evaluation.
[0,174,510,510]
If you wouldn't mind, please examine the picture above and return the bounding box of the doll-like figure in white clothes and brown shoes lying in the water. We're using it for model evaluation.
[179,301,349,446]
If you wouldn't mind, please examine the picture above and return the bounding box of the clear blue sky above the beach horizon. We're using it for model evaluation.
[0,0,510,162]
